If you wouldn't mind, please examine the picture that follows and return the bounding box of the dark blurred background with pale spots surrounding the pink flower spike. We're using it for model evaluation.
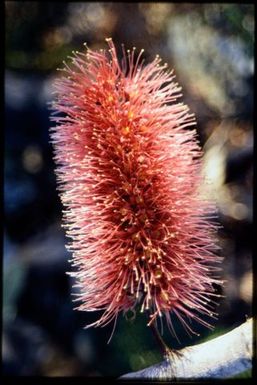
[2,1,254,377]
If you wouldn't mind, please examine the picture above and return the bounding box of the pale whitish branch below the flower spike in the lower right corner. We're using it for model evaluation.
[121,318,253,380]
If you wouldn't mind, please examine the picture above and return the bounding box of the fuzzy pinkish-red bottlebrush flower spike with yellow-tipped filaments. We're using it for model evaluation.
[51,39,220,340]
